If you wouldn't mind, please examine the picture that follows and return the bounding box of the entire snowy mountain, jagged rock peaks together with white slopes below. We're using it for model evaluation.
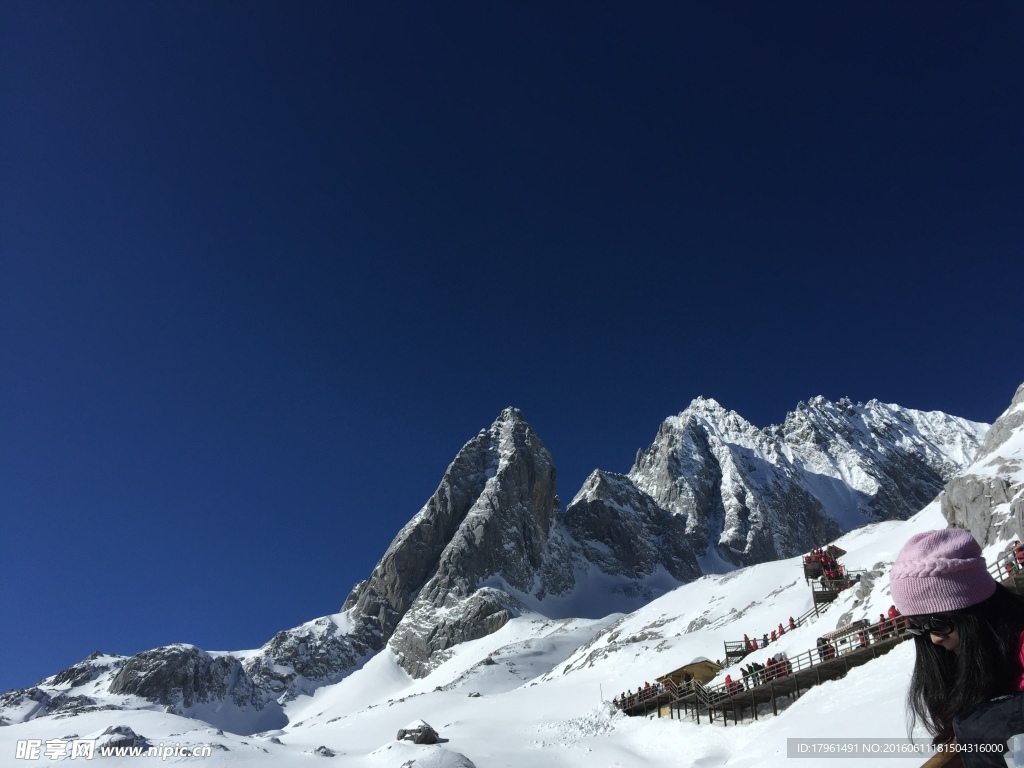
[0,388,1007,767]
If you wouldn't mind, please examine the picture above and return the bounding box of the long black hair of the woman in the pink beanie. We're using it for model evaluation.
[907,585,1024,743]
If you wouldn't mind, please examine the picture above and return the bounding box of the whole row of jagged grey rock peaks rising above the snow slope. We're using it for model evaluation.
[344,398,984,676]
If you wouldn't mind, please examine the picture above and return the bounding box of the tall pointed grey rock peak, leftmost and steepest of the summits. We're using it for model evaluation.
[366,409,573,676]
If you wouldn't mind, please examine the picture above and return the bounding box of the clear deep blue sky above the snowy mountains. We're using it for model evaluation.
[0,0,1024,691]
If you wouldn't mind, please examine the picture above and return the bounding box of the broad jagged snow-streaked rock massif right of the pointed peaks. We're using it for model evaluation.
[629,397,985,564]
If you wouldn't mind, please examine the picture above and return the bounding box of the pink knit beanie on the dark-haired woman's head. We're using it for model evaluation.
[889,528,995,616]
